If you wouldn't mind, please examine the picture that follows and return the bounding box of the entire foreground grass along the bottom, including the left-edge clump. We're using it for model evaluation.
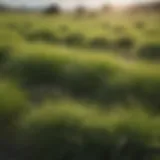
[0,83,160,160]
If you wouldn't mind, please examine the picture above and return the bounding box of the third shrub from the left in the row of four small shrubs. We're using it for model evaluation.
[89,37,110,49]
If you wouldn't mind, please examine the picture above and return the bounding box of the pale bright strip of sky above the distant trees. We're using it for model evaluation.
[0,0,156,8]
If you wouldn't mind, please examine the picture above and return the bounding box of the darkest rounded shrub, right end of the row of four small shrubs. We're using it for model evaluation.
[113,37,135,50]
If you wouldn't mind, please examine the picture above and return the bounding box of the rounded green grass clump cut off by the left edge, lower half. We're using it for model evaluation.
[0,81,27,140]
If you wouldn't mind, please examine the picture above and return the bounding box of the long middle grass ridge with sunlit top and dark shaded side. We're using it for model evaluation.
[2,44,160,109]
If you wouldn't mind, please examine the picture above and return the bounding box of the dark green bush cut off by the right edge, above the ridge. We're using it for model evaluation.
[139,44,160,60]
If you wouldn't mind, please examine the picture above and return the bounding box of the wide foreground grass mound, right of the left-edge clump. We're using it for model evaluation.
[20,101,160,160]
